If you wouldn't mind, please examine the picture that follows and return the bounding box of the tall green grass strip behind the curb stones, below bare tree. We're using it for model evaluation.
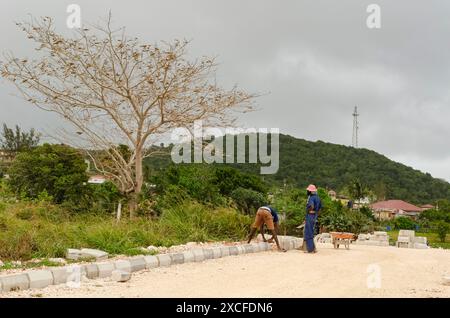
[0,202,251,262]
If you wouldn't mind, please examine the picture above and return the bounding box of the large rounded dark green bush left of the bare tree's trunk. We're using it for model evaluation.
[9,144,87,203]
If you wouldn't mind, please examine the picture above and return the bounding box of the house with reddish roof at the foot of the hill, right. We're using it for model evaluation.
[370,200,423,220]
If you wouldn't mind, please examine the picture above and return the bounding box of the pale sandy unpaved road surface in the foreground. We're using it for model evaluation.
[0,244,450,298]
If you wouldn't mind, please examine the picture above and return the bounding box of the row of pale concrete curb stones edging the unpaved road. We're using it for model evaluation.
[0,237,301,292]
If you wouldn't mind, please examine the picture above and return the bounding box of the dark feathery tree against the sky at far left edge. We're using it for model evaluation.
[0,124,40,159]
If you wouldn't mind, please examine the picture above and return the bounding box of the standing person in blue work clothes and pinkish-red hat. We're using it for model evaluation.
[303,184,322,253]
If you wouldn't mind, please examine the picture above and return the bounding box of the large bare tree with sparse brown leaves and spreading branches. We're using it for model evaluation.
[0,15,256,216]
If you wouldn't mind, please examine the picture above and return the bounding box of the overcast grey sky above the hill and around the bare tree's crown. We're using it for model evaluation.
[0,0,450,180]
